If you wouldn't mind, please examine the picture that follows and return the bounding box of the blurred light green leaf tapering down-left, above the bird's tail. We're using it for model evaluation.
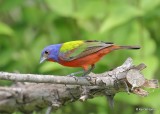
[100,5,142,33]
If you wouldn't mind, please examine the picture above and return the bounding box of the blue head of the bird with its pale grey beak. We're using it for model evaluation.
[40,44,61,63]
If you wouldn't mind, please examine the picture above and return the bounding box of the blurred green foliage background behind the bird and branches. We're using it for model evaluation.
[0,0,160,114]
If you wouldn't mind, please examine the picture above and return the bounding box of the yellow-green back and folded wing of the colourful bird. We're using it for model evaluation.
[59,40,113,61]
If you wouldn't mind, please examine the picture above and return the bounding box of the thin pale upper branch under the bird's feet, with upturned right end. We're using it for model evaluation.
[0,58,132,85]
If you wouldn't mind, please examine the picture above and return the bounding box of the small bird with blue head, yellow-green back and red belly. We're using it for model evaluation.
[40,40,140,75]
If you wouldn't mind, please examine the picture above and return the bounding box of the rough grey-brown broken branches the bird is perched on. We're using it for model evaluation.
[0,58,159,113]
